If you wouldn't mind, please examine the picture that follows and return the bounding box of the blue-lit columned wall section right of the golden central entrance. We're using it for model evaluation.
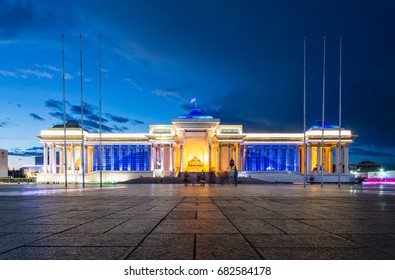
[244,144,299,171]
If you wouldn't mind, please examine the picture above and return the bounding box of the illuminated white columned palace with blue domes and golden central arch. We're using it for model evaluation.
[37,108,355,183]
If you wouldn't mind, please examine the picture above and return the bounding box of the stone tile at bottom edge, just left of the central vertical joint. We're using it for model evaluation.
[128,233,195,260]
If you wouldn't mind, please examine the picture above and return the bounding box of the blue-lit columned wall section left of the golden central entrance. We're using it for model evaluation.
[93,145,151,171]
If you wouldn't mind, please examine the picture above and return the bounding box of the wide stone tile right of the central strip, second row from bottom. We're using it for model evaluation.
[245,234,363,248]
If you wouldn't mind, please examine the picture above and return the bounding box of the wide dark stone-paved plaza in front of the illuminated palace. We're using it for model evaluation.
[0,184,395,260]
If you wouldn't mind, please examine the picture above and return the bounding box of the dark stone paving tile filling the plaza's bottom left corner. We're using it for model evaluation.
[0,247,133,260]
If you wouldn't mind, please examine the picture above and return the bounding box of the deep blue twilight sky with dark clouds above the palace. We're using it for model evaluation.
[0,0,395,168]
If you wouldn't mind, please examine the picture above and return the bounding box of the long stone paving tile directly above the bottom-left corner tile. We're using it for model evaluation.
[29,233,145,247]
